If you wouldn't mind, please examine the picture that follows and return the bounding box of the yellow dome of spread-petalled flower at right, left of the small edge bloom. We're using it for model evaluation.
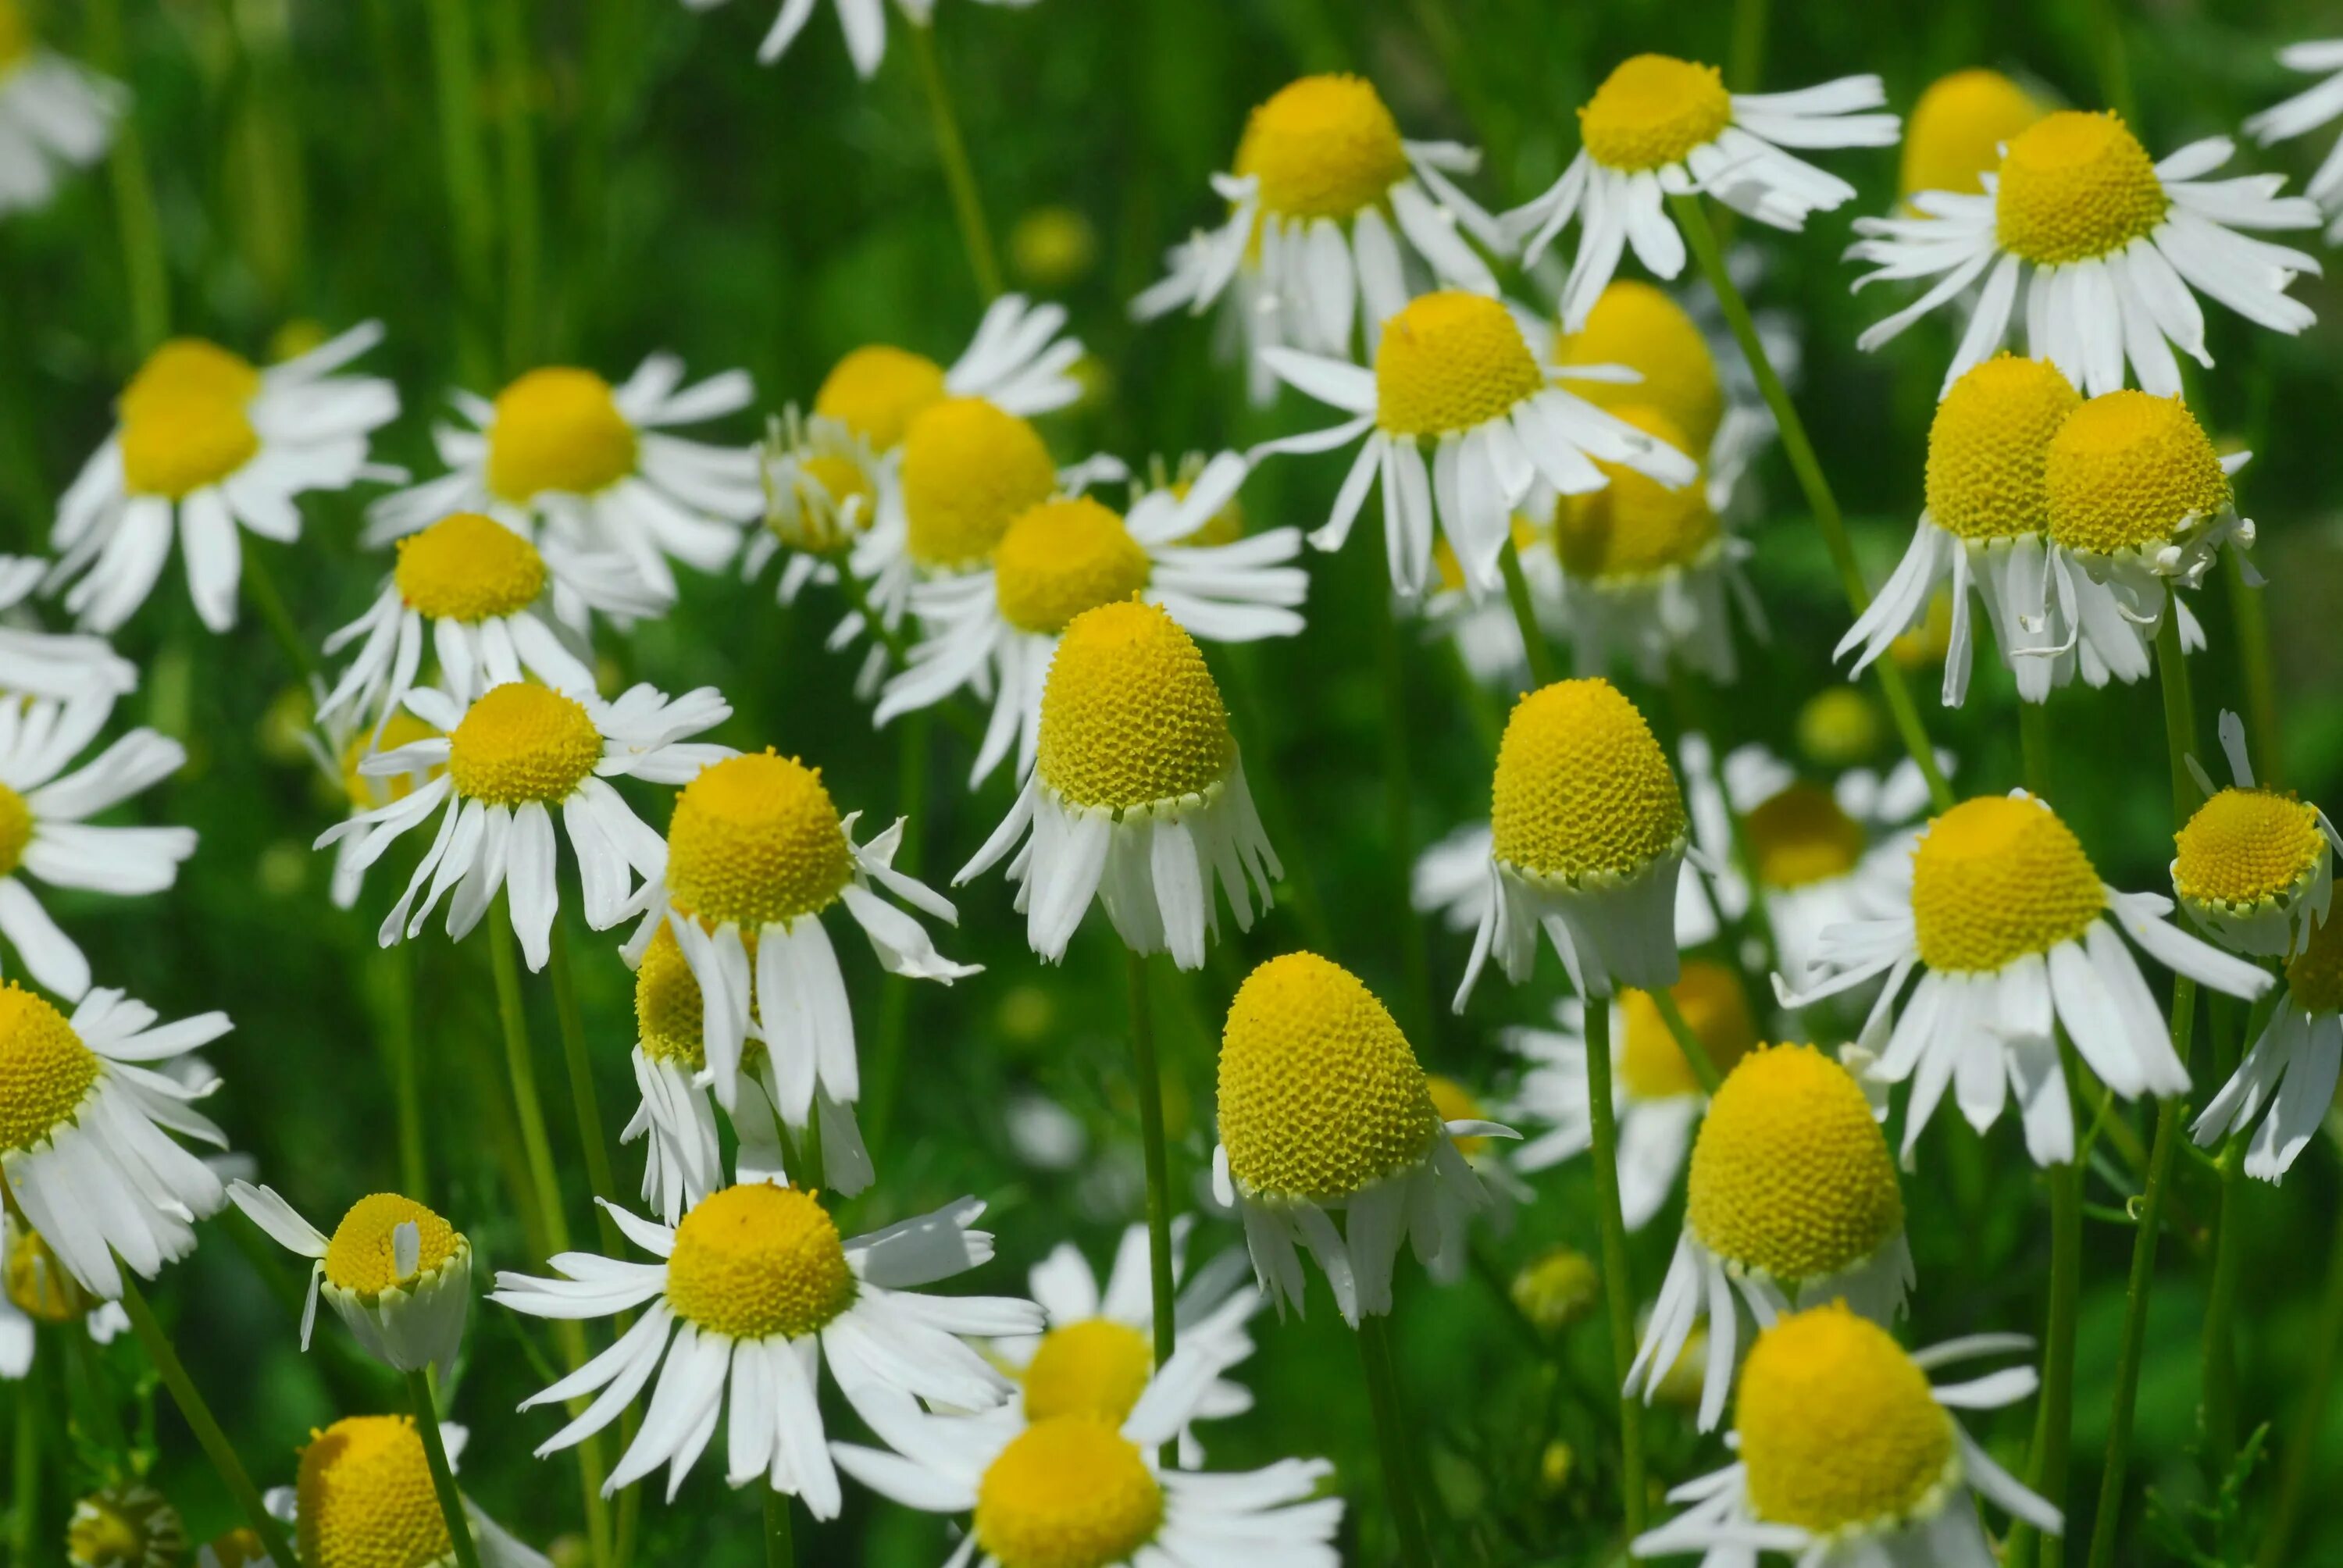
[1912,795,2106,975]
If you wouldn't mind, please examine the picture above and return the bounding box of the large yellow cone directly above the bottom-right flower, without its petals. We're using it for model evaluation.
[1685,1046,1903,1282]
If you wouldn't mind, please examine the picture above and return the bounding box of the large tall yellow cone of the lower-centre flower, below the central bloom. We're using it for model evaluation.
[1221,954,1441,1203]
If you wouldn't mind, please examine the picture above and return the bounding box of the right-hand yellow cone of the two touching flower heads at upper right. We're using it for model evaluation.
[2043,387,2228,555]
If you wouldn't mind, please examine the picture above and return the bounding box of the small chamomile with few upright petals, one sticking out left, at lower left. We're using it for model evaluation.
[227,1181,471,1376]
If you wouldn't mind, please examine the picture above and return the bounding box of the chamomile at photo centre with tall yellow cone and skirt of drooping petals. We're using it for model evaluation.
[951,600,1284,968]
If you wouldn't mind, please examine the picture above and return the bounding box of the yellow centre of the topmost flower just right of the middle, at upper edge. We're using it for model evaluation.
[1237,75,1408,218]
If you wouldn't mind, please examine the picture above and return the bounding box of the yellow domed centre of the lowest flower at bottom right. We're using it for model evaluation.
[1734,1303,1968,1535]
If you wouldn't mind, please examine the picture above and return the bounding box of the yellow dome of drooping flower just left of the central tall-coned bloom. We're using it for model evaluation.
[668,752,855,931]
